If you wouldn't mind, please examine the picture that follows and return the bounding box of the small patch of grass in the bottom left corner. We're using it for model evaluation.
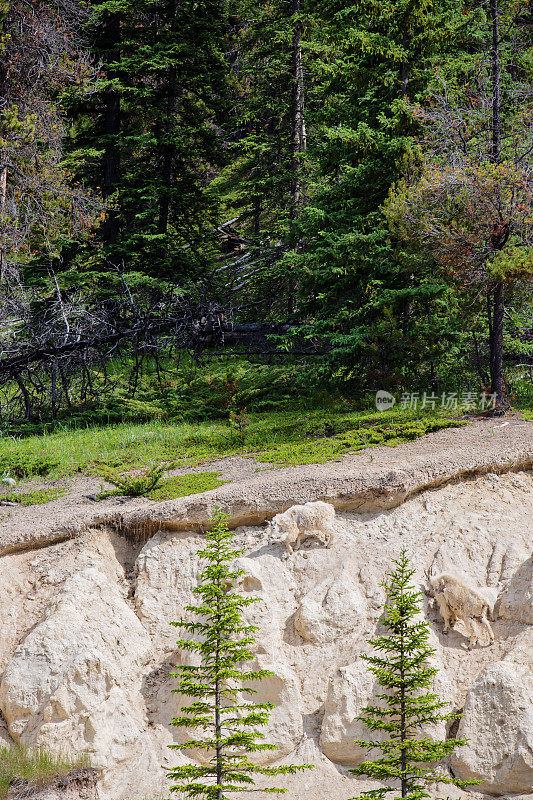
[0,745,90,798]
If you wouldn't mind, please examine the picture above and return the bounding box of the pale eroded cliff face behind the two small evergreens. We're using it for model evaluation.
[0,472,533,800]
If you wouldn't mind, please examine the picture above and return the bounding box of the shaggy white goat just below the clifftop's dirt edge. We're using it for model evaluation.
[269,500,335,555]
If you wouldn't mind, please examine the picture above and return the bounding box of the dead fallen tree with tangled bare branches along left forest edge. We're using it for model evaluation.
[0,282,316,423]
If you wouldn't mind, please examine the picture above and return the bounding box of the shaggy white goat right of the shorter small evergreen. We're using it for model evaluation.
[426,572,494,648]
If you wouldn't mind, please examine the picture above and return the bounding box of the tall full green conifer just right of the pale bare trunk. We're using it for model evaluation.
[281,0,470,392]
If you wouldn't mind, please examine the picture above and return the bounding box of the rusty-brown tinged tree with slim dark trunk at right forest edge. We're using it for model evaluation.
[386,0,533,404]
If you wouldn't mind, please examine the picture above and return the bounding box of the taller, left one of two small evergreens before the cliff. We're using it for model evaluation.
[165,512,310,800]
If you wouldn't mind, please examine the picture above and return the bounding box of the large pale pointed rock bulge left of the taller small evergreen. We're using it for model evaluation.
[0,567,168,797]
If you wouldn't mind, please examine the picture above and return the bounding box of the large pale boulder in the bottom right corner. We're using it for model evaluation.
[452,661,533,795]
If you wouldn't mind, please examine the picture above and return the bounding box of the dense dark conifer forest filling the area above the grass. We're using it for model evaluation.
[0,0,533,432]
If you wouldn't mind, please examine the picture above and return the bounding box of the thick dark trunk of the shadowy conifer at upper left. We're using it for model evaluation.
[102,14,120,245]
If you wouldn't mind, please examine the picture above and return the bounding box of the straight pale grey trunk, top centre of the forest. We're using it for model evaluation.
[291,0,307,219]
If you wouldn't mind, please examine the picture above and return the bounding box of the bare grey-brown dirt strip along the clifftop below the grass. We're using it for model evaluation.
[0,416,533,554]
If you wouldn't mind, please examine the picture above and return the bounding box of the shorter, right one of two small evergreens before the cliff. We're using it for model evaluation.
[350,550,473,800]
